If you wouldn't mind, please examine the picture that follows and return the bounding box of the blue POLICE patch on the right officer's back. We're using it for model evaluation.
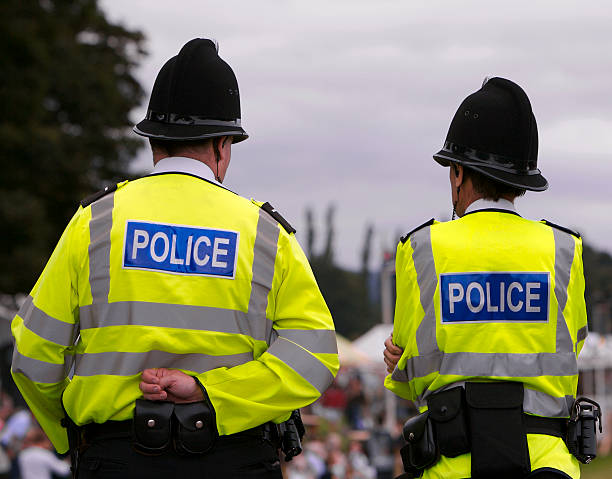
[440,272,550,323]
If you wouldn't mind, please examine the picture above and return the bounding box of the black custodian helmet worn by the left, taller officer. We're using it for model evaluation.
[134,38,249,143]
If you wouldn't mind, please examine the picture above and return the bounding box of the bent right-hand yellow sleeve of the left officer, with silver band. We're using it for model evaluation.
[197,225,339,435]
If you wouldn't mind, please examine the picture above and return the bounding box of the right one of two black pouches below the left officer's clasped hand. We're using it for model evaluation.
[174,401,217,454]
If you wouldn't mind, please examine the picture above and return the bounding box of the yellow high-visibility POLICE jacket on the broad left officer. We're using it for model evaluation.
[12,167,339,452]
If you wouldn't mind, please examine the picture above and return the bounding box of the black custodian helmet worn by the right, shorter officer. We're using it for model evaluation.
[433,77,548,191]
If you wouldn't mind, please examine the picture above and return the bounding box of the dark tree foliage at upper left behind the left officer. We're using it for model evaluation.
[0,0,145,293]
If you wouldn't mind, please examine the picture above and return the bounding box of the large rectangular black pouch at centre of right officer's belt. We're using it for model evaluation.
[465,382,531,479]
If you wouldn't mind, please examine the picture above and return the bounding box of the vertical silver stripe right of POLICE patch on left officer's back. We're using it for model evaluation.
[247,208,279,344]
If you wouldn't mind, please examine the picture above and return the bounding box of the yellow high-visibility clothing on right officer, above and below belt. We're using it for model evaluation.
[385,210,587,479]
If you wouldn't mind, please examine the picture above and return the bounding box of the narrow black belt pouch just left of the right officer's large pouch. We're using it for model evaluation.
[427,386,470,457]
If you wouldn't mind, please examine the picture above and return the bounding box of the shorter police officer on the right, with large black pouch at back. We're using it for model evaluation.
[385,78,587,479]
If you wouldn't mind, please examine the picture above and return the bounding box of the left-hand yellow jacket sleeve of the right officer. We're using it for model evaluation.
[385,241,425,400]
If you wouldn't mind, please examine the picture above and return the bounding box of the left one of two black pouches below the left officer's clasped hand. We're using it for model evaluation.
[132,399,174,456]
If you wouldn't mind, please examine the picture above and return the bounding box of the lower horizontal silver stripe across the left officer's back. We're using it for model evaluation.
[74,351,253,376]
